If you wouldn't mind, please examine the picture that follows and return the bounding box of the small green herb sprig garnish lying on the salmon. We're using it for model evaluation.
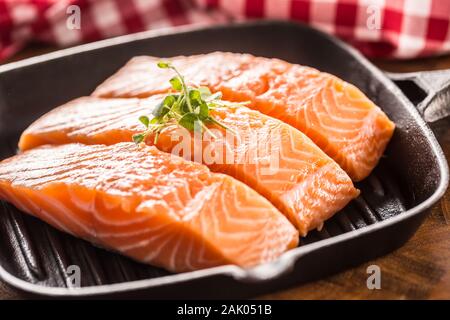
[133,61,236,144]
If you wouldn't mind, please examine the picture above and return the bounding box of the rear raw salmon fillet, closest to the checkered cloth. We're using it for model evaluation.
[93,52,395,181]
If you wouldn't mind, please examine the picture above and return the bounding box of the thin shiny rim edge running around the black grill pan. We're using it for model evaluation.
[0,20,449,297]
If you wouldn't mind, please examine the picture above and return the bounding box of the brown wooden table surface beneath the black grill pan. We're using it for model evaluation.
[0,47,450,299]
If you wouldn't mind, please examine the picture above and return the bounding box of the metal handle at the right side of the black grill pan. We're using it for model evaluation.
[386,69,450,123]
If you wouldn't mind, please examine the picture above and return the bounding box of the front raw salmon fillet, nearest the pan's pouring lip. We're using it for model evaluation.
[0,143,298,272]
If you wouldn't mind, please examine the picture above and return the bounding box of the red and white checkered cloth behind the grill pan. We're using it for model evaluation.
[0,0,450,60]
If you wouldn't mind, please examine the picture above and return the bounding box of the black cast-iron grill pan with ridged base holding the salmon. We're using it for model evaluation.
[0,21,450,298]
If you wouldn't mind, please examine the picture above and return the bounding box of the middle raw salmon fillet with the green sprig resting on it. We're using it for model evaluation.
[19,96,359,235]
